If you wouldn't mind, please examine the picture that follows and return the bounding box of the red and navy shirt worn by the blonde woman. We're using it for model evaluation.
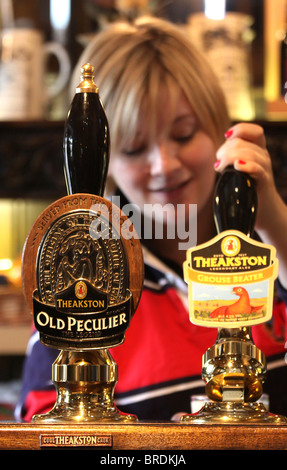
[15,249,287,421]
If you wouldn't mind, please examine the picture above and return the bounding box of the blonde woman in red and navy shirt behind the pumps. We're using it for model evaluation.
[17,19,287,420]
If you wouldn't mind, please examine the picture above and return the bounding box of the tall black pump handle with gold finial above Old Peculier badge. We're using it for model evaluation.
[63,64,110,197]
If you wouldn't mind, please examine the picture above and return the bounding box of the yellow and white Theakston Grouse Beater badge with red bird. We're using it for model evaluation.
[184,230,278,328]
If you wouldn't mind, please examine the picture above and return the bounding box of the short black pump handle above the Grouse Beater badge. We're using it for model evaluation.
[213,166,257,237]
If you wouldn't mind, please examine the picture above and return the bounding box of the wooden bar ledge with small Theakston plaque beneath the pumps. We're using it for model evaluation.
[0,422,287,451]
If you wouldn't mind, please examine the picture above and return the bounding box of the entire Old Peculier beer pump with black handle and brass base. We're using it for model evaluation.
[22,64,143,424]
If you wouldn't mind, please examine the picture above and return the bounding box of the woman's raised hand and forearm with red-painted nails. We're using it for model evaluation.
[214,123,287,288]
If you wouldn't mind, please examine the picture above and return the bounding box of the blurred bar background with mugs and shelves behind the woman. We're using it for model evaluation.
[0,0,287,419]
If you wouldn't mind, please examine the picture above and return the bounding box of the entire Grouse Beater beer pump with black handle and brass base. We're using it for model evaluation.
[181,167,287,425]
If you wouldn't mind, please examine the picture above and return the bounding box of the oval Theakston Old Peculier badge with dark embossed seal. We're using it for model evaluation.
[24,194,142,349]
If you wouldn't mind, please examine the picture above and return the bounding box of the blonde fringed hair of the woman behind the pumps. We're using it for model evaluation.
[72,17,229,148]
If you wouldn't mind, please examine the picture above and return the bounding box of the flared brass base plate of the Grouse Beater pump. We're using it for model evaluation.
[181,402,287,426]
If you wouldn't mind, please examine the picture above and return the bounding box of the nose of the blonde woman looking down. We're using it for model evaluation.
[149,143,180,176]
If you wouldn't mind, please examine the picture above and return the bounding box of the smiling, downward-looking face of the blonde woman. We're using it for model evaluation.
[109,89,216,226]
